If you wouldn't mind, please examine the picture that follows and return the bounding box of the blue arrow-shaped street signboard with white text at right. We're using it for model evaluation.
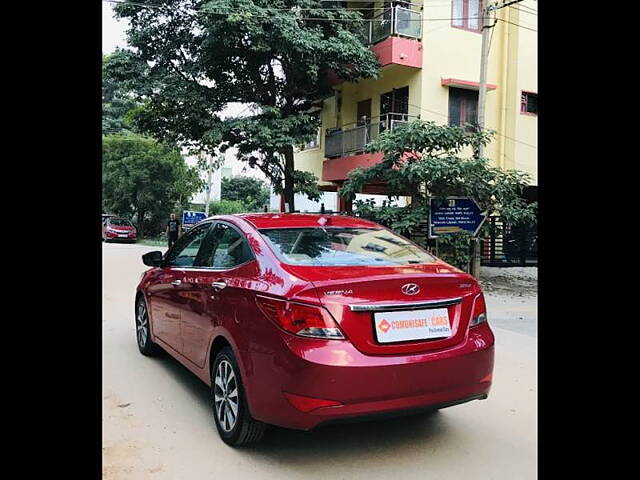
[429,197,486,238]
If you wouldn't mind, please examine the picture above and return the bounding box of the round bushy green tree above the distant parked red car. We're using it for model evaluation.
[102,135,203,236]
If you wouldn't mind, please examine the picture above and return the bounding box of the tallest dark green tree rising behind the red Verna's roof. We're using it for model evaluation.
[109,0,379,210]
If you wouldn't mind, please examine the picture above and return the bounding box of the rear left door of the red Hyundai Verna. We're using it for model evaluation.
[182,222,257,368]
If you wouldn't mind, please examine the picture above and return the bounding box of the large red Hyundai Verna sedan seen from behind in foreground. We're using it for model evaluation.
[135,213,494,445]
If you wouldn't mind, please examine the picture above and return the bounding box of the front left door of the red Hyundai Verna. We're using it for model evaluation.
[148,222,211,353]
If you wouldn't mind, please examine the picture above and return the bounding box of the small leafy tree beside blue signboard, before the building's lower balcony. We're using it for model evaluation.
[341,120,537,269]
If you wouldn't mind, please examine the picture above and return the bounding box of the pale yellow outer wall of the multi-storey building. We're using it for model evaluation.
[296,0,538,185]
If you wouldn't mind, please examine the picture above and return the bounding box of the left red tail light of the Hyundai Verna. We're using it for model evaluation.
[256,296,344,340]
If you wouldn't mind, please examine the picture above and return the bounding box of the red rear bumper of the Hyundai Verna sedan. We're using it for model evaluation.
[247,324,494,430]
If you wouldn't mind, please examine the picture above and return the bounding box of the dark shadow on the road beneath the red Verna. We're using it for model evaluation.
[149,346,455,467]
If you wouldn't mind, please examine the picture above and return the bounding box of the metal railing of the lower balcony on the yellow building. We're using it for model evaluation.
[324,113,417,158]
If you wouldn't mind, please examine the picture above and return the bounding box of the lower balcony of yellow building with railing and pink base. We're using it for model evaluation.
[322,113,417,182]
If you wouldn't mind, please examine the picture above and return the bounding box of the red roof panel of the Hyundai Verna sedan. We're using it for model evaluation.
[231,213,380,229]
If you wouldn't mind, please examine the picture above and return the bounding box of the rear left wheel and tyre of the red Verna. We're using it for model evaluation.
[211,347,267,447]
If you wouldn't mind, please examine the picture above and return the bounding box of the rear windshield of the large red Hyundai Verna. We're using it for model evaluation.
[260,227,435,266]
